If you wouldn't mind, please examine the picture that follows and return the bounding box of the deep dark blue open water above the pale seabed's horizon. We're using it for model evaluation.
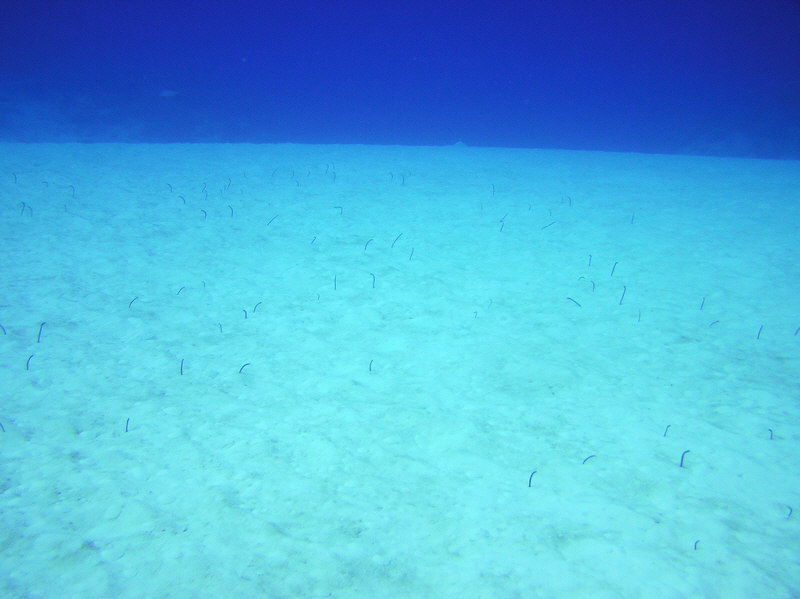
[0,0,800,158]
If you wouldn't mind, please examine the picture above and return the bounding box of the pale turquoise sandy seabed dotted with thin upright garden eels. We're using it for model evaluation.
[0,144,800,599]
